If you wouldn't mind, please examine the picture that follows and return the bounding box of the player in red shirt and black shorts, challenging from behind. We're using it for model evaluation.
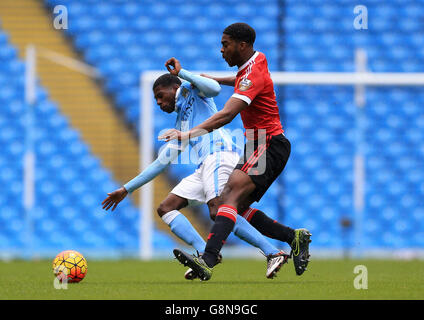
[159,23,311,280]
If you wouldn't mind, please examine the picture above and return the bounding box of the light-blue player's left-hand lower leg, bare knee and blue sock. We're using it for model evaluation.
[157,193,206,252]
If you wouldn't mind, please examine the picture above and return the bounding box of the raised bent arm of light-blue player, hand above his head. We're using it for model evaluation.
[165,58,221,98]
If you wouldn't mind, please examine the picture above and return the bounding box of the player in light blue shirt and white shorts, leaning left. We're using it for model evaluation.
[102,58,287,279]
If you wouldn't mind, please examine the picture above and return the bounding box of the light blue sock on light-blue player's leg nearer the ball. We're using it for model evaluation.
[162,210,206,253]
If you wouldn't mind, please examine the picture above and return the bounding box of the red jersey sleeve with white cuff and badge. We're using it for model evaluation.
[232,67,264,105]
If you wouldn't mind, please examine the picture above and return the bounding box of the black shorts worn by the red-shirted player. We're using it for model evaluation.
[234,134,291,201]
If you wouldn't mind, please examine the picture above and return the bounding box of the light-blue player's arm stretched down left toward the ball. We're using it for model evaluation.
[102,143,184,211]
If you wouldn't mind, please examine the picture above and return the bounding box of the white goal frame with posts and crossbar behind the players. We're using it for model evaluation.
[139,49,424,260]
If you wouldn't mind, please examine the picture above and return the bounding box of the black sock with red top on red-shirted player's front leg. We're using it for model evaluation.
[202,205,237,267]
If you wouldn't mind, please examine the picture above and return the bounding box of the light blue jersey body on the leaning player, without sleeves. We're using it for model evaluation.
[175,81,241,165]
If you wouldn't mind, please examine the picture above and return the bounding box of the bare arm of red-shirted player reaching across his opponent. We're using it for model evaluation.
[159,97,248,141]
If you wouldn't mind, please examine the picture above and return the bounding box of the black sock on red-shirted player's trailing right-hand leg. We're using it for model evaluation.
[248,209,295,245]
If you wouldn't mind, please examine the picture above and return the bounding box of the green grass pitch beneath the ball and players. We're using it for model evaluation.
[0,259,424,300]
